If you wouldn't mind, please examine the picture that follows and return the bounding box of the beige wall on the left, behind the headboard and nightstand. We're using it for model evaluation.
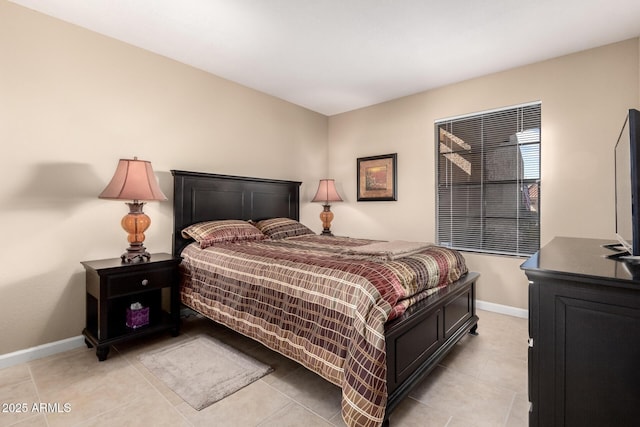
[0,0,327,355]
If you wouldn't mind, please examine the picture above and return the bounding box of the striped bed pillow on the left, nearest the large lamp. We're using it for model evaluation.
[182,219,267,249]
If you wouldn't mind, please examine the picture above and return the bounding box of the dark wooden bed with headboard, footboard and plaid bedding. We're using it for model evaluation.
[171,170,478,426]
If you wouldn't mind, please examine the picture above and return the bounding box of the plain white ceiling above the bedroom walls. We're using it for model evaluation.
[11,0,640,115]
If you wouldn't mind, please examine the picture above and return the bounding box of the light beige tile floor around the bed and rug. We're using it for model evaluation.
[0,311,528,427]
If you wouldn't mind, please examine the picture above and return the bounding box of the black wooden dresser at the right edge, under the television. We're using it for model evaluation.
[521,237,640,427]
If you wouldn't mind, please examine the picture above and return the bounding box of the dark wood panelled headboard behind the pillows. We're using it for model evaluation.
[171,170,301,255]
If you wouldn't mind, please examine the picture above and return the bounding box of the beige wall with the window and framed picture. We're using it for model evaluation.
[329,39,640,309]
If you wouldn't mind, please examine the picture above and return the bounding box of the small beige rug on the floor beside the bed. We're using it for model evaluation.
[139,335,272,411]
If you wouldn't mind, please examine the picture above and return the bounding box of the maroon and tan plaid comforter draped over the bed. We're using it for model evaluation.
[180,235,467,426]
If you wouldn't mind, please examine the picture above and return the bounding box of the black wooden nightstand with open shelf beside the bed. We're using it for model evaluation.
[81,253,181,361]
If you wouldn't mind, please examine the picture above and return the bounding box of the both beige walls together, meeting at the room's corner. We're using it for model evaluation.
[0,0,640,355]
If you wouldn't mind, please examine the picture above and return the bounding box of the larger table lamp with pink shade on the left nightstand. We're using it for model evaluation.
[98,157,167,262]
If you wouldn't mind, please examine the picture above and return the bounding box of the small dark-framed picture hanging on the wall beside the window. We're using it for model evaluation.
[357,153,398,202]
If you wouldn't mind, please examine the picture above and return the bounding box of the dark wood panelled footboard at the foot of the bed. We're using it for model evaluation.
[385,273,479,425]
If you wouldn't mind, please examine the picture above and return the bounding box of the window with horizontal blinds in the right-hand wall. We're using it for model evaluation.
[435,102,541,256]
